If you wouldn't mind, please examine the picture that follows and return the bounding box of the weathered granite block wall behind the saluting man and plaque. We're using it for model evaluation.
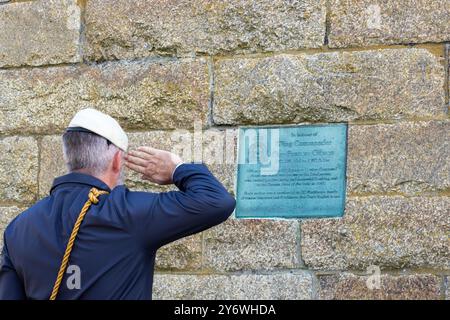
[0,0,450,299]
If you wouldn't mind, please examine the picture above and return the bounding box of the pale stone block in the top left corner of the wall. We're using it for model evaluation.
[0,0,81,67]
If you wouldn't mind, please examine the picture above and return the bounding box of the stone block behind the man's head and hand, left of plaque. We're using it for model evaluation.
[39,129,237,197]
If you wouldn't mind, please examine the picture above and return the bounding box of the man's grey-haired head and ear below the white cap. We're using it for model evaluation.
[63,131,120,176]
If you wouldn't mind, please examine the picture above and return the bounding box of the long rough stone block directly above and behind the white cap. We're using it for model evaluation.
[0,59,209,133]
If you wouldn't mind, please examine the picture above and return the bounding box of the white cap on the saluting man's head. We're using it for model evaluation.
[67,108,128,151]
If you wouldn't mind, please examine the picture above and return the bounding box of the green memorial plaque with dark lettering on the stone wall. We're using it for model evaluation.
[236,124,347,218]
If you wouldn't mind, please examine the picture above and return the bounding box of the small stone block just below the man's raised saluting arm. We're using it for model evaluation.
[156,233,202,271]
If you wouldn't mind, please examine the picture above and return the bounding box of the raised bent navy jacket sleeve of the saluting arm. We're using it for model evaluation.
[127,164,236,249]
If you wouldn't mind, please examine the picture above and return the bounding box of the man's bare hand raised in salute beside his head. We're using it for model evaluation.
[125,147,183,185]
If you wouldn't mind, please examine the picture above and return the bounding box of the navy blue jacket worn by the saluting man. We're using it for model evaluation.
[0,164,235,299]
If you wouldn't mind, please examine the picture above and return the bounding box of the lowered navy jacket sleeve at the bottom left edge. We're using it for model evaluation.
[0,238,26,300]
